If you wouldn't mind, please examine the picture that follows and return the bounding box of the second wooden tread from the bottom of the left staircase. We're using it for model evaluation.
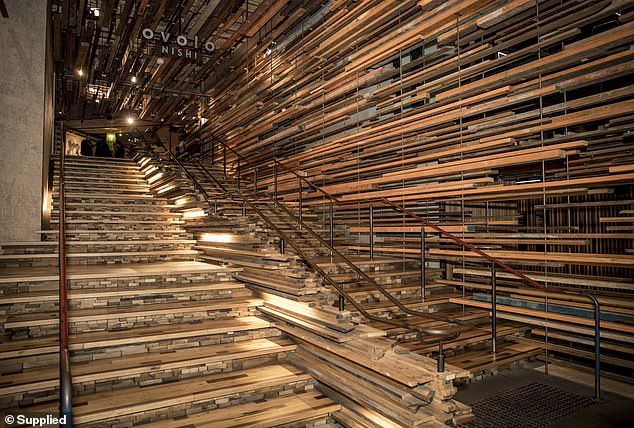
[21,364,311,425]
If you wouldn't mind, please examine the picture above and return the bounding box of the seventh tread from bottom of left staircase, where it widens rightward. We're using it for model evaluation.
[0,261,235,284]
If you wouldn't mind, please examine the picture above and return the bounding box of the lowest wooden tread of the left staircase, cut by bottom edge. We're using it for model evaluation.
[144,391,341,428]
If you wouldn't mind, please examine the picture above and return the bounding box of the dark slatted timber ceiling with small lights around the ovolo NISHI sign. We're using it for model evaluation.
[52,0,322,132]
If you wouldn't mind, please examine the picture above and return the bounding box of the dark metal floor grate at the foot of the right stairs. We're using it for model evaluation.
[461,382,594,428]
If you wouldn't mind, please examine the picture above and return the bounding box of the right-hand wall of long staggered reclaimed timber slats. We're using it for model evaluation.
[194,0,634,293]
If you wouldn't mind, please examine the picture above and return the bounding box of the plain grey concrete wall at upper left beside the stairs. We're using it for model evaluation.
[0,0,52,241]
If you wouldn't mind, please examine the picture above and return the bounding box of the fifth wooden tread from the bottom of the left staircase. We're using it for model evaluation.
[5,299,263,329]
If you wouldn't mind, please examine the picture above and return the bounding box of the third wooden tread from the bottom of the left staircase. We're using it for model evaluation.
[0,338,296,395]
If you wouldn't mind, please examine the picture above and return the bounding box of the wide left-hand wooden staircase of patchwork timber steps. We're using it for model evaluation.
[0,157,340,426]
